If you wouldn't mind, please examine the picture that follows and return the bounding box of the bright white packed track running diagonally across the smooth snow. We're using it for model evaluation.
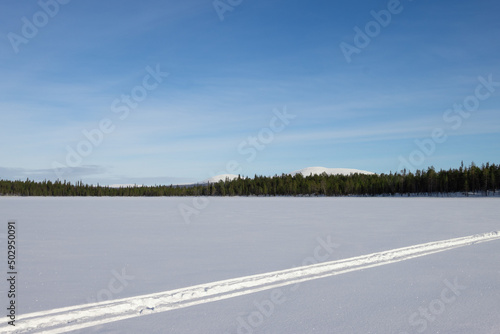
[4,231,500,334]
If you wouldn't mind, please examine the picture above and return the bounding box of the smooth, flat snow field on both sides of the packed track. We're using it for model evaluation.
[0,197,500,334]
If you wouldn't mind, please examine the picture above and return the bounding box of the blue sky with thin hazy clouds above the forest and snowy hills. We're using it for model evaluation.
[0,0,500,184]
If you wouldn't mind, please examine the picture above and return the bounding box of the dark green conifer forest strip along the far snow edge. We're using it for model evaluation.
[0,163,500,196]
